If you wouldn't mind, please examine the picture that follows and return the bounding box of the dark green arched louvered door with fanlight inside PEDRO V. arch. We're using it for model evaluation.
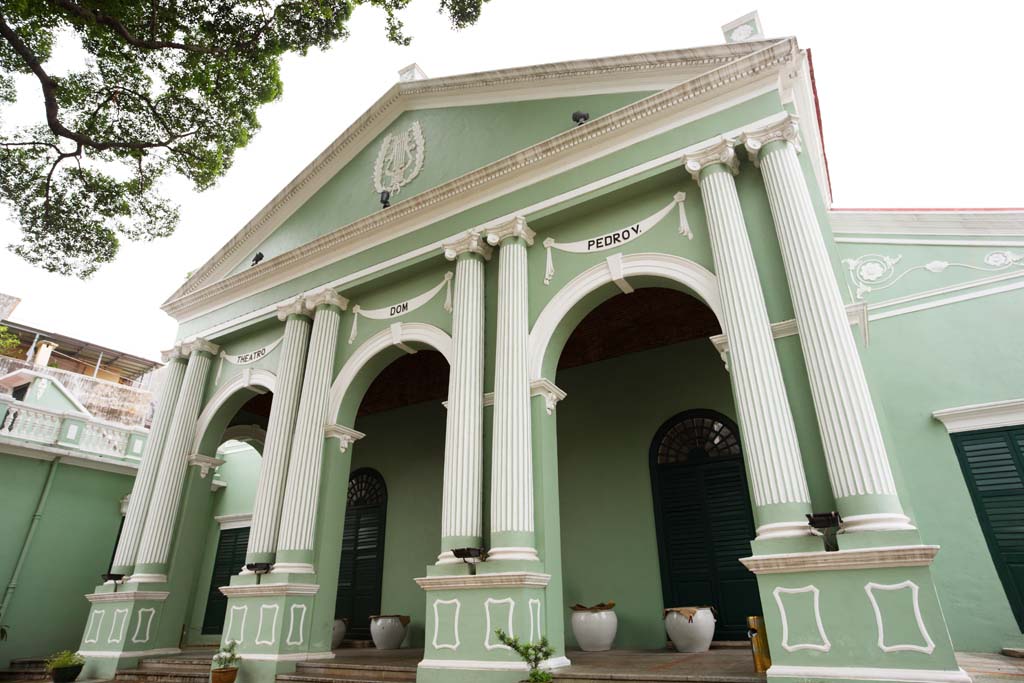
[651,411,761,640]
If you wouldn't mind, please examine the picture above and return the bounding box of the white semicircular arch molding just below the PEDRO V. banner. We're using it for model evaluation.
[529,253,725,380]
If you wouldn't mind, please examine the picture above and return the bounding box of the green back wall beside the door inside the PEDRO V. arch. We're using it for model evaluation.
[557,339,735,648]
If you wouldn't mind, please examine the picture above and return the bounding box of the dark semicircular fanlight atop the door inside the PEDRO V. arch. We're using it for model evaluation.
[657,411,740,465]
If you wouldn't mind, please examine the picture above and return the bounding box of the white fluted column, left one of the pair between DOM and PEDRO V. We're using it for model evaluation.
[437,232,492,564]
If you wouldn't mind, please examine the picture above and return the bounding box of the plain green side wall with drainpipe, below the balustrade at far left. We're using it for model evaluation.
[0,453,134,669]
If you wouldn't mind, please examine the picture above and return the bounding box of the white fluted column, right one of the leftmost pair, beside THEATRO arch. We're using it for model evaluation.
[133,339,220,582]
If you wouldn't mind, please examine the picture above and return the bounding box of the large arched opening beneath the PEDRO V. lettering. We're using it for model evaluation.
[552,286,760,658]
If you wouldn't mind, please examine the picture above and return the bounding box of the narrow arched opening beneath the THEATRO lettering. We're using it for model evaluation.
[184,387,273,645]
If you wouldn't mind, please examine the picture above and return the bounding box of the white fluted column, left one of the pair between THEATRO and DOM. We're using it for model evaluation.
[246,298,312,564]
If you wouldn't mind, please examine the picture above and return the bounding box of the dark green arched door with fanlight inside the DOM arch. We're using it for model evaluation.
[335,467,387,640]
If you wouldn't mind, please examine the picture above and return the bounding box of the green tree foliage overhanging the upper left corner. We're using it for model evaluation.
[0,0,486,278]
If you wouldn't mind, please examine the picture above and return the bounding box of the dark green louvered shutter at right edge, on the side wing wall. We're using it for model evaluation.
[952,427,1024,630]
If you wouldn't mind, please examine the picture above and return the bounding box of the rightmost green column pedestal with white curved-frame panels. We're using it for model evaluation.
[741,544,970,683]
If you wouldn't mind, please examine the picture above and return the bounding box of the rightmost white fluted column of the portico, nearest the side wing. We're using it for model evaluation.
[744,116,913,531]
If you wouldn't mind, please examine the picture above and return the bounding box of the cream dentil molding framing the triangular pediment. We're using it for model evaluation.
[163,38,797,321]
